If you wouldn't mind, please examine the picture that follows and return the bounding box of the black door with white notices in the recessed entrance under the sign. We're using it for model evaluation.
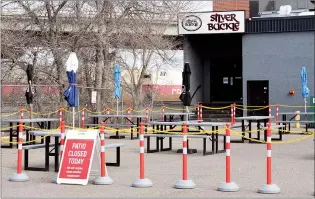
[210,57,243,104]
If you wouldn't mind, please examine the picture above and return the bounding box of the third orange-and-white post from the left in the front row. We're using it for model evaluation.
[132,122,153,188]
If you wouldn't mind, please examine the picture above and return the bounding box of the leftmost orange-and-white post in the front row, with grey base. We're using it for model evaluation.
[9,119,29,182]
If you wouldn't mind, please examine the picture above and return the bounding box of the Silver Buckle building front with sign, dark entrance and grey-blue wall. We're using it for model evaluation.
[178,10,315,115]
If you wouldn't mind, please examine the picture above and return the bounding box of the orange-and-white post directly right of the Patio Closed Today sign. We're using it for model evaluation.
[93,122,113,185]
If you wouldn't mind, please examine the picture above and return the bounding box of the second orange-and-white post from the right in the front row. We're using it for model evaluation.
[218,124,240,192]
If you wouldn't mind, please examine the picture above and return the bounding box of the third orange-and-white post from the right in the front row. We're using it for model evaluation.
[174,123,196,189]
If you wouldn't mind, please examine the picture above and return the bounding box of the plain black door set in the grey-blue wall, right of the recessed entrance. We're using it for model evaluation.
[247,80,269,116]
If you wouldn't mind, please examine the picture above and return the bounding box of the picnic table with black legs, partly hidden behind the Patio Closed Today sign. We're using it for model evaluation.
[26,130,125,172]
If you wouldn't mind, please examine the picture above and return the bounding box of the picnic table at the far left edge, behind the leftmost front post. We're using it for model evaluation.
[1,118,59,148]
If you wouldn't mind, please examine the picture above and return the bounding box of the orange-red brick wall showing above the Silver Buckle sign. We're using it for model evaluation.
[213,0,250,19]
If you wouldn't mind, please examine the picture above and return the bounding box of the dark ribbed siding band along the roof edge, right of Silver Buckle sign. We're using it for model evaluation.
[245,16,315,33]
